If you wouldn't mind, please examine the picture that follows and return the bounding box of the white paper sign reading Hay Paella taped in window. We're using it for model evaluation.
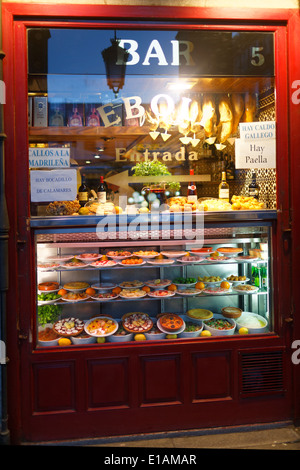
[235,139,276,169]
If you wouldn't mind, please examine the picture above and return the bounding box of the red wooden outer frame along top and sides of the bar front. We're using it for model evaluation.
[3,3,300,441]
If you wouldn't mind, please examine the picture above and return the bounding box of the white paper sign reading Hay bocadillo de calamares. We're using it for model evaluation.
[30,169,77,202]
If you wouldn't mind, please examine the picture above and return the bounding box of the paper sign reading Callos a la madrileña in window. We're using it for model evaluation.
[29,147,70,168]
